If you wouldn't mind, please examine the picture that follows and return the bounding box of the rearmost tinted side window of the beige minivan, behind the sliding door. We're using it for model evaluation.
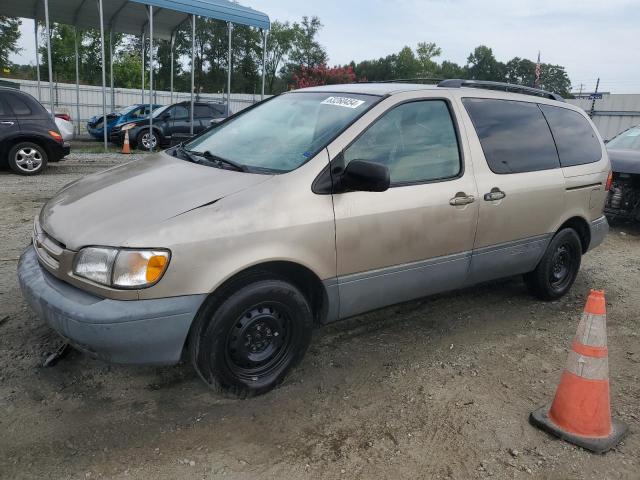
[540,105,602,167]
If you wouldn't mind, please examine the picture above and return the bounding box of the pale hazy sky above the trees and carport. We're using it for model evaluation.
[12,0,640,93]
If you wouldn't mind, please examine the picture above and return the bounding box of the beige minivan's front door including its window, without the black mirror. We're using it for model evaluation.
[333,99,478,318]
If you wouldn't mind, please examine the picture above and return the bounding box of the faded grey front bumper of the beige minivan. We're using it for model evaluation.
[18,245,205,364]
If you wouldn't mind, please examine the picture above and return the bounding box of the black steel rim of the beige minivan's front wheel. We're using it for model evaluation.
[225,302,293,381]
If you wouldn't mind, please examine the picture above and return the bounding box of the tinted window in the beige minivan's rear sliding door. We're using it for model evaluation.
[462,98,560,174]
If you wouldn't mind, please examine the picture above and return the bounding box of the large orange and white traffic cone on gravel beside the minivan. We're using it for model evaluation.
[529,290,628,453]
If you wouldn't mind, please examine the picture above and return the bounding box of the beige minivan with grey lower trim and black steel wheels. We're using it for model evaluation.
[18,80,611,396]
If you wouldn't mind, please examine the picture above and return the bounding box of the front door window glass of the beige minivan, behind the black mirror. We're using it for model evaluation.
[344,100,461,185]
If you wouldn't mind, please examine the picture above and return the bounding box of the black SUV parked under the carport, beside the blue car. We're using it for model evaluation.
[109,102,227,150]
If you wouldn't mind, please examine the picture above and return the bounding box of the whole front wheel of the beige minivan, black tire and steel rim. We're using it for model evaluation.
[189,274,313,398]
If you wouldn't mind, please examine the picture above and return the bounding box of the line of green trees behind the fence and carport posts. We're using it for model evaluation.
[0,16,571,96]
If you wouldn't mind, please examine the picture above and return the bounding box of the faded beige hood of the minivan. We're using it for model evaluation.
[40,153,271,250]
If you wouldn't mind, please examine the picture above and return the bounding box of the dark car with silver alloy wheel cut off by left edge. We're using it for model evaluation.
[0,87,70,175]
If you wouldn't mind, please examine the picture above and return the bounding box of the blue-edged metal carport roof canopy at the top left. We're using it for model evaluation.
[2,0,270,39]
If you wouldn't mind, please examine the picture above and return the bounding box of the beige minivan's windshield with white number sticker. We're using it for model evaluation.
[185,92,381,173]
